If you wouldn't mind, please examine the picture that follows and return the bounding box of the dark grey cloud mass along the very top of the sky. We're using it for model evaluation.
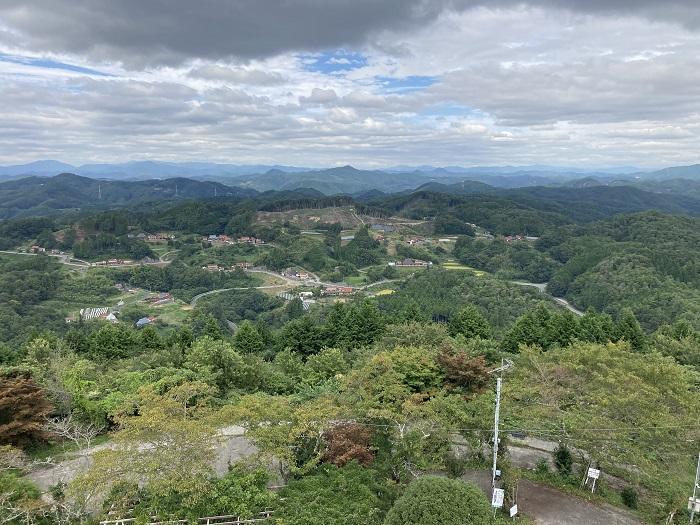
[0,0,700,67]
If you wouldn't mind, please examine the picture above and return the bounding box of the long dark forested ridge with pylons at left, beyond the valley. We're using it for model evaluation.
[0,173,257,219]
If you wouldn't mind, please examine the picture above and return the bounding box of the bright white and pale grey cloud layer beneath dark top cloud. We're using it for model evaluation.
[0,0,700,166]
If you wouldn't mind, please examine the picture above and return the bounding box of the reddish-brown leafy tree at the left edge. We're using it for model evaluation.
[0,373,53,446]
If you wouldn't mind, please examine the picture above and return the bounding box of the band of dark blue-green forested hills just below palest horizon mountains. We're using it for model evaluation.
[0,170,700,220]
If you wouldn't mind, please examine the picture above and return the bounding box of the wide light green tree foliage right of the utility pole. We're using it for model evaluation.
[502,343,700,512]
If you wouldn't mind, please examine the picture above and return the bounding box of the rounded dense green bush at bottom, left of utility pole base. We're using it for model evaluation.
[384,476,491,525]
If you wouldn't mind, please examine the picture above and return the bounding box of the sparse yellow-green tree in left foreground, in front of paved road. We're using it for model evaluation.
[69,385,215,517]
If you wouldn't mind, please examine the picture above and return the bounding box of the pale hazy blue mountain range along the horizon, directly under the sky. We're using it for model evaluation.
[0,160,700,195]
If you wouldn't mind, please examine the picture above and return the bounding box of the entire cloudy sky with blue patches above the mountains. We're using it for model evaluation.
[0,0,700,167]
